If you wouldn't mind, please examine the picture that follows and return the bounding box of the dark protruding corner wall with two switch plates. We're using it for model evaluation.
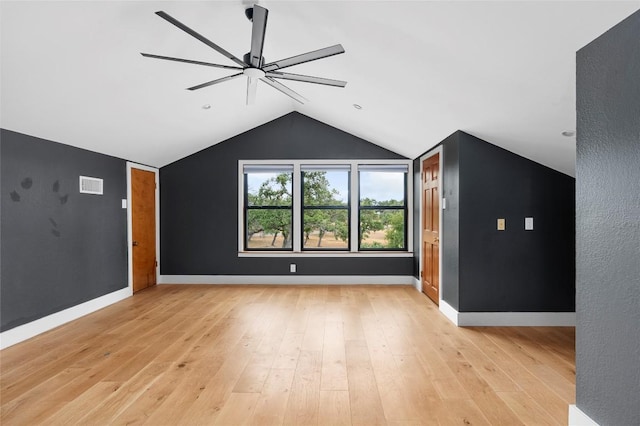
[414,131,575,312]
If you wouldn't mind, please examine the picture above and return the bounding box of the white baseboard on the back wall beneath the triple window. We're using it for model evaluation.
[158,274,414,285]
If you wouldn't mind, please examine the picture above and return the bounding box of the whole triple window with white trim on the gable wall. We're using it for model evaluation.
[238,160,411,256]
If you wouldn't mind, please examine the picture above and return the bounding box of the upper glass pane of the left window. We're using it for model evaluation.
[245,172,292,206]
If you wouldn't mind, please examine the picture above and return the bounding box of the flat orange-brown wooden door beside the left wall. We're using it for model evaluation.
[131,168,157,293]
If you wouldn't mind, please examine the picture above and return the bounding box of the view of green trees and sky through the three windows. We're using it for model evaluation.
[245,165,407,250]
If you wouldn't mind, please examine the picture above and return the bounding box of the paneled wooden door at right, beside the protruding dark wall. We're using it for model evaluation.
[420,154,440,305]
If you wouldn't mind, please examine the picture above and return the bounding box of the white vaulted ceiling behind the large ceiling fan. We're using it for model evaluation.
[0,0,640,175]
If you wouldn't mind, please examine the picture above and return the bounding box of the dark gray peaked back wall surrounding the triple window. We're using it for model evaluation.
[160,112,413,275]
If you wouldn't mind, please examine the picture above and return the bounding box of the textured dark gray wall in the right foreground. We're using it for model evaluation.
[576,11,640,425]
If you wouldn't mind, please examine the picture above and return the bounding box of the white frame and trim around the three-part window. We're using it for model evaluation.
[238,159,414,257]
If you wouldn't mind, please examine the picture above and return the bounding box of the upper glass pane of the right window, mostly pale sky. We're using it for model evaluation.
[360,170,406,206]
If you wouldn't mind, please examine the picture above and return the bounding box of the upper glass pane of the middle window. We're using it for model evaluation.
[302,169,349,206]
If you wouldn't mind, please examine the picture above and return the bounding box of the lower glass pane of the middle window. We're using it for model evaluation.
[302,209,349,249]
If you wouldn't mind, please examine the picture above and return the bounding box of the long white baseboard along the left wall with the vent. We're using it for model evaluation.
[0,287,133,349]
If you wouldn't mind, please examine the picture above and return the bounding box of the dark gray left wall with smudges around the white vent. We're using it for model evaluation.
[0,130,127,331]
